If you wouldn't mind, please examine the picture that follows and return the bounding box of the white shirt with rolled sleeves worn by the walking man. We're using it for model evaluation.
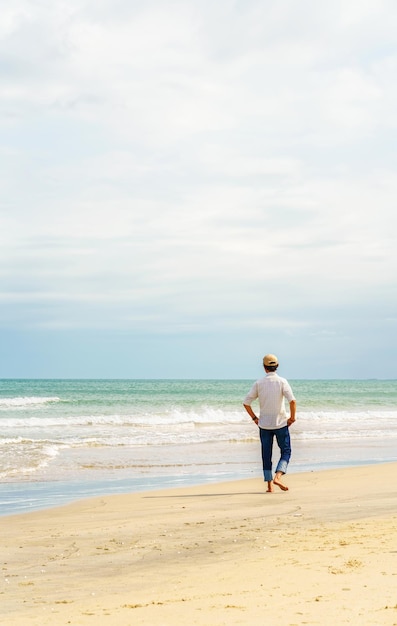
[244,372,295,429]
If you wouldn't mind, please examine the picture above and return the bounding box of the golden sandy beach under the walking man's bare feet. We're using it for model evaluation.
[0,464,397,626]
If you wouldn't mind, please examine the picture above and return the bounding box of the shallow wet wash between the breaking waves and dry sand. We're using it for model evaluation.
[0,438,397,519]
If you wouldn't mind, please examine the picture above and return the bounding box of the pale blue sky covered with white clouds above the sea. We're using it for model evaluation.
[0,0,397,379]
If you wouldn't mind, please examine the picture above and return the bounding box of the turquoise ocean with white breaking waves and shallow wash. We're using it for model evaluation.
[0,379,397,515]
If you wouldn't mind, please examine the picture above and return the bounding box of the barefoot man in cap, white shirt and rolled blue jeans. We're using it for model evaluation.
[244,354,296,493]
